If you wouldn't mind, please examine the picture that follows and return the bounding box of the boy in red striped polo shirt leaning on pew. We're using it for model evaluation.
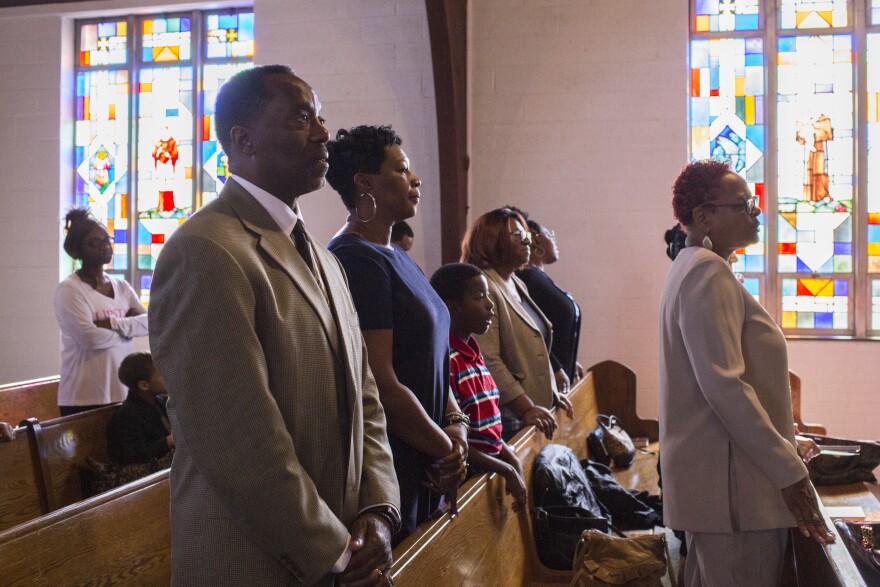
[431,263,526,512]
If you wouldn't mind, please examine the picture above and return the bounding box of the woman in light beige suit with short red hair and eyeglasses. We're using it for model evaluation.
[660,160,834,587]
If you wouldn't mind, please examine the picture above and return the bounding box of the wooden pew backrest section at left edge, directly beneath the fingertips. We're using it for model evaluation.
[0,428,46,531]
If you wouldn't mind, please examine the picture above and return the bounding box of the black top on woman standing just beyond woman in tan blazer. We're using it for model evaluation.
[516,265,581,379]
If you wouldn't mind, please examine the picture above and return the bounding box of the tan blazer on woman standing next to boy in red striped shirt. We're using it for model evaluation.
[477,269,556,417]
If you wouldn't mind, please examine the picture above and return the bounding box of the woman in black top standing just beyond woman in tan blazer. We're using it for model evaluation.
[516,215,584,391]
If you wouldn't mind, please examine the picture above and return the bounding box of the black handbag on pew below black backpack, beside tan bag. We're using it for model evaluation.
[532,506,608,570]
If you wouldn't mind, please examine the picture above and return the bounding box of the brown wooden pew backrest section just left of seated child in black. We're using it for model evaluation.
[26,404,119,511]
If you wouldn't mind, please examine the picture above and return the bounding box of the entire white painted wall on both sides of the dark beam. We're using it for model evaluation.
[0,0,880,437]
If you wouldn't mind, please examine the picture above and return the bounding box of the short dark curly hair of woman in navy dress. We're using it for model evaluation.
[327,125,403,210]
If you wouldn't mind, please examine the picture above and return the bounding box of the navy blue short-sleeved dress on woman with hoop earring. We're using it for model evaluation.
[327,234,449,542]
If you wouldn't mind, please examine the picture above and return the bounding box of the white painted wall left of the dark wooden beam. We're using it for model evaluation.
[0,0,440,383]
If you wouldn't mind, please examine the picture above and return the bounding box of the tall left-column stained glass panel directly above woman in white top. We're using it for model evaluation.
[74,70,129,271]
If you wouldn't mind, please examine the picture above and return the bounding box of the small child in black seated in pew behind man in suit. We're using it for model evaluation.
[107,353,174,465]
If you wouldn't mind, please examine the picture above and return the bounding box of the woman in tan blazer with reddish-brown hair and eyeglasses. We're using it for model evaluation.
[461,208,574,440]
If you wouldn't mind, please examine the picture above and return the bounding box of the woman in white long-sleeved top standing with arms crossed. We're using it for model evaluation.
[55,208,148,416]
